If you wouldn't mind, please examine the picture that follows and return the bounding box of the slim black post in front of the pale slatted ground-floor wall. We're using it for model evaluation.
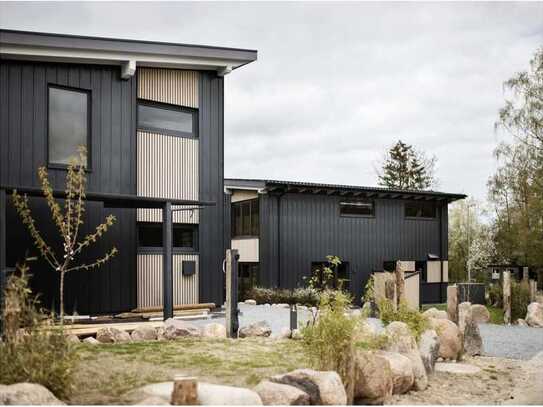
[162,202,173,321]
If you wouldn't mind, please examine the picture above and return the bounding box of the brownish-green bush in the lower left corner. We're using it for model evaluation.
[0,266,76,398]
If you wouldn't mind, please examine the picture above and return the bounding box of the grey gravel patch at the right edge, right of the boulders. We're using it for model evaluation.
[479,324,543,360]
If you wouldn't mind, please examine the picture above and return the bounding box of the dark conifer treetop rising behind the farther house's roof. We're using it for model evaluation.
[377,140,437,190]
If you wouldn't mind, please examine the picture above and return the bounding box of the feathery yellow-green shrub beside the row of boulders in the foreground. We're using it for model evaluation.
[302,291,360,404]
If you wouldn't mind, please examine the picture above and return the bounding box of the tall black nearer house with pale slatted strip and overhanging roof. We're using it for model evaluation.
[0,30,257,314]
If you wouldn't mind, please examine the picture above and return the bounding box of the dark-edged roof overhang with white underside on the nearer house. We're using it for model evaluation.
[0,30,257,79]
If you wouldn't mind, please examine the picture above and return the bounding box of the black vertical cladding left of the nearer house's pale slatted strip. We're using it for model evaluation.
[0,60,137,314]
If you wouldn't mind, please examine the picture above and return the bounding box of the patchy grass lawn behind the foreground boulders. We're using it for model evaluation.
[67,338,309,404]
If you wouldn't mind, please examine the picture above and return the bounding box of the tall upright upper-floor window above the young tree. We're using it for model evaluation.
[48,85,90,167]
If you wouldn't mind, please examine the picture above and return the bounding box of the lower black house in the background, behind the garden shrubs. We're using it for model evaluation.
[225,179,466,303]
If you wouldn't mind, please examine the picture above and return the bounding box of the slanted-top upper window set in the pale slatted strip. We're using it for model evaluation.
[138,100,198,138]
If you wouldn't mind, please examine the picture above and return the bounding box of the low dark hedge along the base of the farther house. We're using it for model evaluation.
[243,287,320,307]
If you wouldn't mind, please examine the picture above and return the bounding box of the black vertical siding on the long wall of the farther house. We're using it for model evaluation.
[260,193,447,301]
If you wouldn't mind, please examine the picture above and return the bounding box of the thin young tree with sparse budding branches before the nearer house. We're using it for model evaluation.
[12,147,117,323]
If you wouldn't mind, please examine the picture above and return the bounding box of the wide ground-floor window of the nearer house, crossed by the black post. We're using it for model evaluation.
[138,222,198,251]
